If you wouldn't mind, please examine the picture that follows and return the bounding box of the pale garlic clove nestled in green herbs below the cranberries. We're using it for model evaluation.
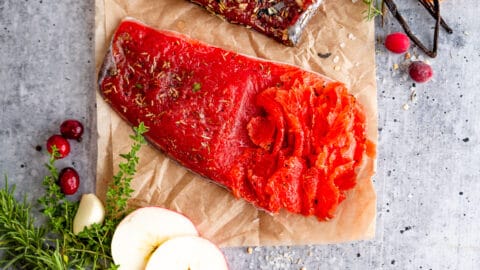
[73,193,105,235]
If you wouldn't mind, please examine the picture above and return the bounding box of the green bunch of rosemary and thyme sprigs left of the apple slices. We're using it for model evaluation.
[0,123,148,270]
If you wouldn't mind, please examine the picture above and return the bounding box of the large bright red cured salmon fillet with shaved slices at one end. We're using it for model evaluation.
[98,20,366,220]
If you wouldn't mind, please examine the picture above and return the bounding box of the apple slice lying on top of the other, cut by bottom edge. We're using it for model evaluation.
[145,236,228,270]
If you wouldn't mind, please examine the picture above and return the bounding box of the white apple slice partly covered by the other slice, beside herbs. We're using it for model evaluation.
[112,207,198,270]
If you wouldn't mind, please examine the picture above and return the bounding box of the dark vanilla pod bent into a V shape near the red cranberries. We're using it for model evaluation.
[384,0,440,58]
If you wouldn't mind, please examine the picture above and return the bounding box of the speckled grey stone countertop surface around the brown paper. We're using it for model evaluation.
[0,0,480,270]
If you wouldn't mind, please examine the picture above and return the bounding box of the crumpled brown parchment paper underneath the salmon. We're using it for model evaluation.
[95,0,377,246]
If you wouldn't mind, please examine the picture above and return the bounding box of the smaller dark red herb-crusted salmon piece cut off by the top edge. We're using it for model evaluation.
[190,0,322,46]
